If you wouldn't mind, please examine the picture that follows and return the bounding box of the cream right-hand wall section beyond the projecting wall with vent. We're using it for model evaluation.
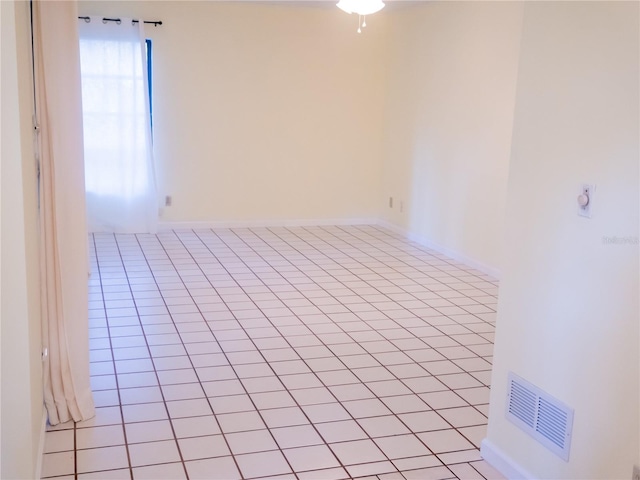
[378,2,522,273]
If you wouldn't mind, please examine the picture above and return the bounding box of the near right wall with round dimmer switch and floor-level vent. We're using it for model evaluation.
[484,2,640,479]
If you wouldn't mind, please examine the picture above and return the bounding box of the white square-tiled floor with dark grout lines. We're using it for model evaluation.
[43,226,508,480]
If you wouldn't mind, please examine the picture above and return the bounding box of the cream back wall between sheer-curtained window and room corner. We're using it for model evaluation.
[79,1,386,222]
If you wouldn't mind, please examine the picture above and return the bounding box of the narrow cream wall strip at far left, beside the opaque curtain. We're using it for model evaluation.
[0,2,43,479]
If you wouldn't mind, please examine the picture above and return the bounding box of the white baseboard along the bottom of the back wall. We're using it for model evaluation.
[158,218,378,232]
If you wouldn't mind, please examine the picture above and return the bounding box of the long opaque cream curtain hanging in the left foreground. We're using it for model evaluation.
[32,1,95,425]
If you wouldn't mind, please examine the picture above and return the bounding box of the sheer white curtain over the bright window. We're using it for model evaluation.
[79,17,158,233]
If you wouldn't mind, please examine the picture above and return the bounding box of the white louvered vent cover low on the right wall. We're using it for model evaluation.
[507,372,573,461]
